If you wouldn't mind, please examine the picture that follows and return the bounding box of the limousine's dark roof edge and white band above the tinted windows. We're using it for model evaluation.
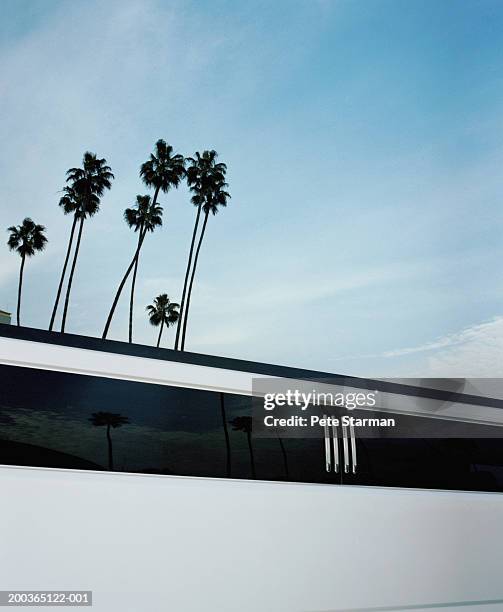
[0,325,503,426]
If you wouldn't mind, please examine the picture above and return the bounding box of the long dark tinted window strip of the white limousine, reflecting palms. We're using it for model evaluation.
[4,365,503,491]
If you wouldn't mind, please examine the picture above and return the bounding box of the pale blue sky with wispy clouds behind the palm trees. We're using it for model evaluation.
[0,0,503,376]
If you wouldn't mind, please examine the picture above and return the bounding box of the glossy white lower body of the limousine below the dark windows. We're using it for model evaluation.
[0,468,503,612]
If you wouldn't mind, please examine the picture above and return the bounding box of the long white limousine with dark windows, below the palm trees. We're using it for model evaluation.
[0,325,503,612]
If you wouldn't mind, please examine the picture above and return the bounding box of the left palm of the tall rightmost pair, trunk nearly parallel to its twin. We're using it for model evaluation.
[175,150,227,350]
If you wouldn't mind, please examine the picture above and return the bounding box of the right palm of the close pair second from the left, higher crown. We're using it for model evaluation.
[61,151,115,332]
